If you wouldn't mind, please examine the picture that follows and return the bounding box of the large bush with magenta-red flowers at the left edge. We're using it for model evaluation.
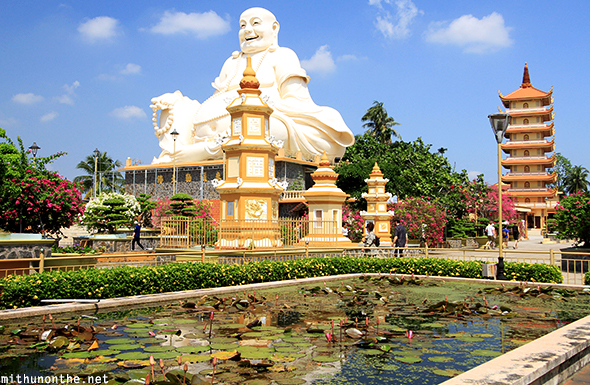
[0,129,84,234]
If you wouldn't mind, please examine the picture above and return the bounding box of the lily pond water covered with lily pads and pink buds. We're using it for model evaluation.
[0,276,590,385]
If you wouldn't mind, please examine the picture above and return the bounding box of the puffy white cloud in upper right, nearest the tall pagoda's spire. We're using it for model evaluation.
[426,12,513,53]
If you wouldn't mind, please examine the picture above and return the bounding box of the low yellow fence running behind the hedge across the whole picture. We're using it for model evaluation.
[0,243,590,285]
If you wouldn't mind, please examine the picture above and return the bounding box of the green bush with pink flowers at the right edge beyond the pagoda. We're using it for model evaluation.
[554,192,590,247]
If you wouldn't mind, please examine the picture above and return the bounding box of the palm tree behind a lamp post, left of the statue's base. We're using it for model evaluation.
[74,151,124,198]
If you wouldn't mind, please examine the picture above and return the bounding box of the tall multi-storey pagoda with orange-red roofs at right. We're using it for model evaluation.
[500,63,557,229]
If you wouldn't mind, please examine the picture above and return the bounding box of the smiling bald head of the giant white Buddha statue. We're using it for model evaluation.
[238,8,279,54]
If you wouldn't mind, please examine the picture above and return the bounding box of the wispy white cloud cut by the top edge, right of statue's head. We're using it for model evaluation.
[369,0,423,39]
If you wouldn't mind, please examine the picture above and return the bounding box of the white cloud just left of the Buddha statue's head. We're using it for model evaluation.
[150,11,231,39]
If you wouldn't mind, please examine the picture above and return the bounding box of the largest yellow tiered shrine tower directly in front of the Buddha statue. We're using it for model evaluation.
[216,57,285,249]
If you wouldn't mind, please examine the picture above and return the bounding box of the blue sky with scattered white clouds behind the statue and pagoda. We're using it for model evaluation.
[0,0,590,183]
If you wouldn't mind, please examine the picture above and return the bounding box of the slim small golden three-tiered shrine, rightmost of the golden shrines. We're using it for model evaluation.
[361,162,393,246]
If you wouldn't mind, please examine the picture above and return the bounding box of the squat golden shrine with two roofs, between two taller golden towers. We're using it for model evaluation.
[300,152,352,247]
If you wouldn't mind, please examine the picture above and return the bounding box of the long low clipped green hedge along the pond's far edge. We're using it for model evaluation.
[0,256,562,309]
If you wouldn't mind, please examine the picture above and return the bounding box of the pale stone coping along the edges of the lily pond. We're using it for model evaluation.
[0,273,590,385]
